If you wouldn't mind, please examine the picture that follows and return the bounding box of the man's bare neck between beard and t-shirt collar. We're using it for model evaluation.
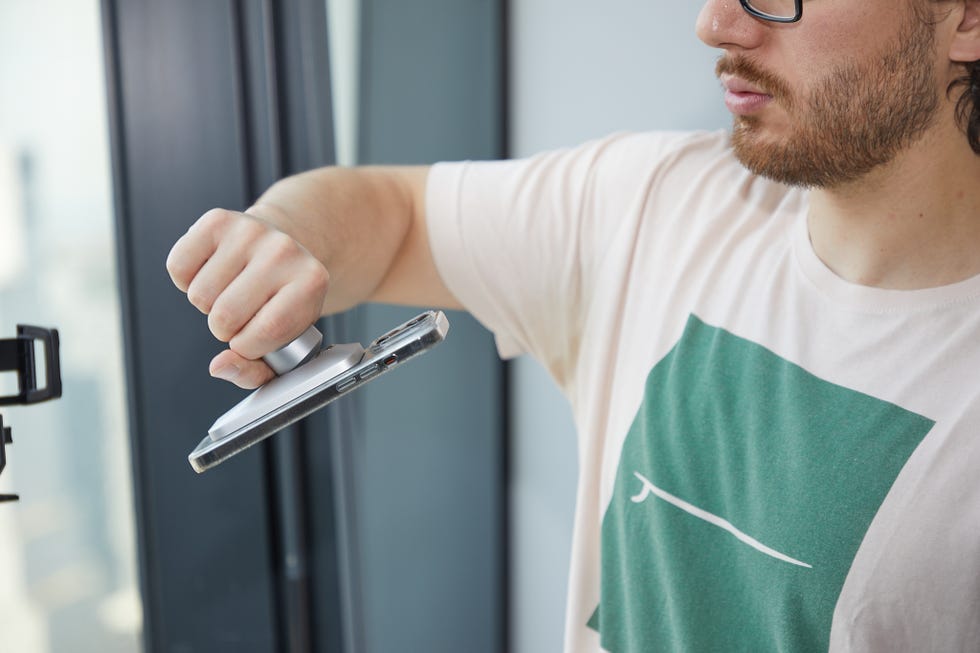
[809,121,980,290]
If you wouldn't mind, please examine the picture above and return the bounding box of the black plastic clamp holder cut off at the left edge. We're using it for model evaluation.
[0,324,61,502]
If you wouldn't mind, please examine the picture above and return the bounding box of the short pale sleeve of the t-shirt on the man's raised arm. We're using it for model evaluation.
[426,134,708,385]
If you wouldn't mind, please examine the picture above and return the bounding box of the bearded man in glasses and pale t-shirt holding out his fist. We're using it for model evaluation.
[168,0,980,651]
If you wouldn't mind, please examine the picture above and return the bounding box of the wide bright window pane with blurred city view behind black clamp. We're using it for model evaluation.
[0,0,142,653]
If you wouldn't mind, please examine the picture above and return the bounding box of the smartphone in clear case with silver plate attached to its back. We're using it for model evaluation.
[188,311,449,473]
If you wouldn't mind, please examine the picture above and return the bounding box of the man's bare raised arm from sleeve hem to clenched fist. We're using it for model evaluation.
[167,167,458,388]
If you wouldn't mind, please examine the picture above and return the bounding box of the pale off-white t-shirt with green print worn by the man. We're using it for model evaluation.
[427,133,980,653]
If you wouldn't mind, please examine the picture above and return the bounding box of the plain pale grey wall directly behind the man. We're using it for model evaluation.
[509,0,730,653]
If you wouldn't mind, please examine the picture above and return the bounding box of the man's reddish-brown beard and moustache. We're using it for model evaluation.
[716,16,940,188]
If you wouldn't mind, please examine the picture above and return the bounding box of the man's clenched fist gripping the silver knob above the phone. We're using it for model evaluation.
[167,209,329,388]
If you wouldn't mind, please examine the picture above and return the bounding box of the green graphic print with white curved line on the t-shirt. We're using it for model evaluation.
[589,315,933,653]
